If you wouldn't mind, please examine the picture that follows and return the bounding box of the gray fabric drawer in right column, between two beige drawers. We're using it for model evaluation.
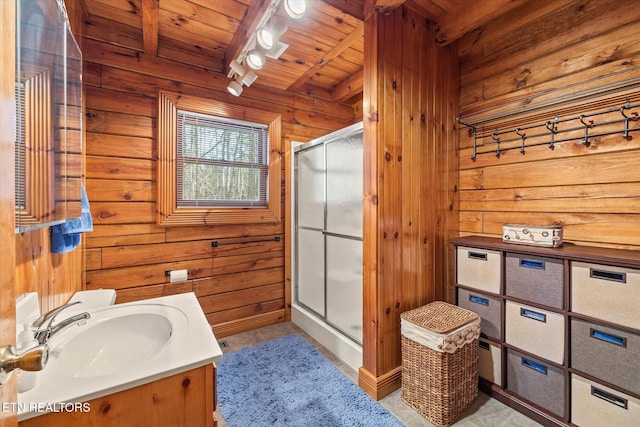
[571,318,640,394]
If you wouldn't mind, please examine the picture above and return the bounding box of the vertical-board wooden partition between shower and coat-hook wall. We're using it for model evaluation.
[359,6,458,399]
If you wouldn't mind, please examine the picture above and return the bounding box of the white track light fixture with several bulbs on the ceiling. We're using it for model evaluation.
[227,0,306,96]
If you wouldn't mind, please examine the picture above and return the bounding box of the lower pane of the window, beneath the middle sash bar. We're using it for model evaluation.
[182,163,265,202]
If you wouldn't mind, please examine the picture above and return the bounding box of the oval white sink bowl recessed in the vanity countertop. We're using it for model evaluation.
[51,304,187,378]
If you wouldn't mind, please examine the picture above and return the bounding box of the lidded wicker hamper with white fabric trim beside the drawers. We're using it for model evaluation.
[400,301,480,426]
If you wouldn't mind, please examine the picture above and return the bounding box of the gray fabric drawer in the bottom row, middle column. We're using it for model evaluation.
[507,349,565,417]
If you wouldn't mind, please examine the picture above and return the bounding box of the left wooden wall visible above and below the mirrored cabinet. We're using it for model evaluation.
[15,0,85,312]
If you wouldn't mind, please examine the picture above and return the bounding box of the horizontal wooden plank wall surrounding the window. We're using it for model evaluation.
[79,15,356,337]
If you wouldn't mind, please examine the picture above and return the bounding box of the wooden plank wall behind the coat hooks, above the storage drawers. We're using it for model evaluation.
[458,0,640,298]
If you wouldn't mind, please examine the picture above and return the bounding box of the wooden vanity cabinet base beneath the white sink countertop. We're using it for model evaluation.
[18,364,217,427]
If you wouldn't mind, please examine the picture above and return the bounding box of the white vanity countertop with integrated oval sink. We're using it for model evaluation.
[18,292,222,421]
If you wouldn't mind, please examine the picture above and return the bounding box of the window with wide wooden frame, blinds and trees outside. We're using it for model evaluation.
[157,92,281,225]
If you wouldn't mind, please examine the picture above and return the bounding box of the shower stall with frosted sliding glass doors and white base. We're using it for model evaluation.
[291,123,363,370]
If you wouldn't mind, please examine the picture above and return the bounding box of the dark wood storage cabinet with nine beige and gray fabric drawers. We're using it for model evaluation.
[451,236,640,427]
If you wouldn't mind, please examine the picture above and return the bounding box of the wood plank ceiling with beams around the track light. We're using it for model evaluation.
[83,0,525,102]
